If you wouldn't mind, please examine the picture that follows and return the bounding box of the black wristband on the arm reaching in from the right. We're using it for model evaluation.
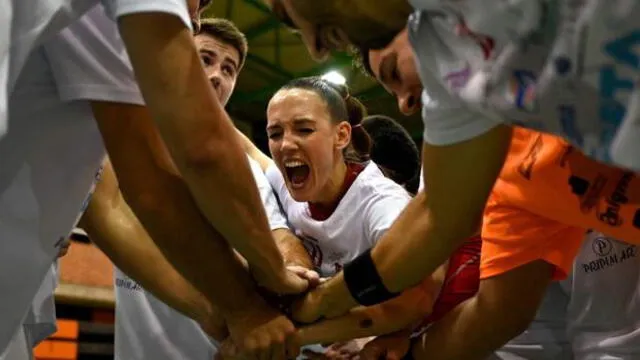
[343,249,399,306]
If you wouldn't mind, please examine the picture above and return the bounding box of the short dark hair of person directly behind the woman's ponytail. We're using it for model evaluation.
[362,115,421,194]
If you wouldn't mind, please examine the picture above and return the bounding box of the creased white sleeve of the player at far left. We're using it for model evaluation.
[44,4,144,105]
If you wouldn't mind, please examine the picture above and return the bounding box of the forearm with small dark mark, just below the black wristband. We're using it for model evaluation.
[298,265,446,345]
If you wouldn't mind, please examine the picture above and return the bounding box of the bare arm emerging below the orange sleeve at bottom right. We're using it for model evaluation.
[412,260,553,360]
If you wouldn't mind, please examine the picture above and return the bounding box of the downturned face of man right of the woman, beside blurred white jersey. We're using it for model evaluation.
[369,28,422,115]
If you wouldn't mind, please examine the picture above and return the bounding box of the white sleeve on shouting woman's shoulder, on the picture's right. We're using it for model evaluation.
[364,193,411,244]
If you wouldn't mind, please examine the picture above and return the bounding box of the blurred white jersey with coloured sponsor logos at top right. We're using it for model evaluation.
[409,0,640,170]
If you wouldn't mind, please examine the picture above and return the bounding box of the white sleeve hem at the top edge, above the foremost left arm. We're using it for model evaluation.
[102,0,193,30]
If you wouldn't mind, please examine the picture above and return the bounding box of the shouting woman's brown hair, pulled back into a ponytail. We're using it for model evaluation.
[281,76,371,162]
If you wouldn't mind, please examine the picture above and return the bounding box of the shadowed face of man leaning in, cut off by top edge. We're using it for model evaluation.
[265,0,411,60]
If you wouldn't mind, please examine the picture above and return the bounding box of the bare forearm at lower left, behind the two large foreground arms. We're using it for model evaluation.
[80,160,228,341]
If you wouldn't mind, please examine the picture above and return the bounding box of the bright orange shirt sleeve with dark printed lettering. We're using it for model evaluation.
[480,128,640,279]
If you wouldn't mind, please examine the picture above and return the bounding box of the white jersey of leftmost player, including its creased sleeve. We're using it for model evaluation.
[0,6,142,349]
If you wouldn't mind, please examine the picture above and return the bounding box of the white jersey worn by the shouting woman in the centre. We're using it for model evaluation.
[266,162,411,277]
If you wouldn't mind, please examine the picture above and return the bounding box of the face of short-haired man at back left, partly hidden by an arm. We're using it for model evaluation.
[195,33,240,105]
